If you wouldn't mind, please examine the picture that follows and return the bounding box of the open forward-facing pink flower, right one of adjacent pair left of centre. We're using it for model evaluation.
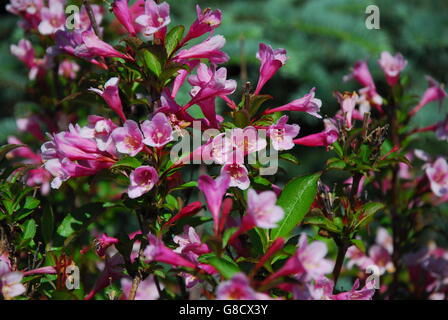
[142,112,173,148]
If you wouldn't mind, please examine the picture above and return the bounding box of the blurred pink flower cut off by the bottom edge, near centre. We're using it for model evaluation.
[216,273,257,300]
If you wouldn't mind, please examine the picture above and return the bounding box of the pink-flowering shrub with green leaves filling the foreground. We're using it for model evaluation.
[0,0,448,300]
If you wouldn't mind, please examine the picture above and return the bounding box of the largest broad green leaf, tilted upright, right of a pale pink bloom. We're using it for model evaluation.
[271,173,320,240]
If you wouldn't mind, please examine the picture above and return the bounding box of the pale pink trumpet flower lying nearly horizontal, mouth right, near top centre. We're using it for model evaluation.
[174,35,229,64]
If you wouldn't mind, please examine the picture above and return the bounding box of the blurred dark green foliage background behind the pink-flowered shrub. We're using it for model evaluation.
[0,0,448,176]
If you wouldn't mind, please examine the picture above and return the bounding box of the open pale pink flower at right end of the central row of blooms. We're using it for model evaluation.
[268,116,300,151]
